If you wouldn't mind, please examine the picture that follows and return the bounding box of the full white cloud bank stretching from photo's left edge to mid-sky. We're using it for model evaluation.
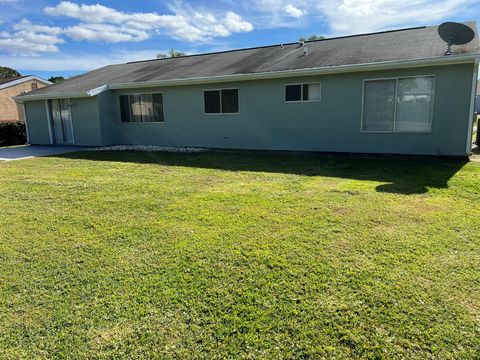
[0,0,253,55]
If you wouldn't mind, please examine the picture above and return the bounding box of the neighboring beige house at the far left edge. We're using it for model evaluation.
[0,76,52,121]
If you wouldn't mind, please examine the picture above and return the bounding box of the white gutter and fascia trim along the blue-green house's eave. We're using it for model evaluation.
[14,54,480,102]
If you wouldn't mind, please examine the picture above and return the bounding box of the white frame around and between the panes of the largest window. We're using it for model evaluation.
[360,75,437,134]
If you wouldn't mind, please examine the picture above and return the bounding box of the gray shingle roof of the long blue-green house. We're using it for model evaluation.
[23,22,480,95]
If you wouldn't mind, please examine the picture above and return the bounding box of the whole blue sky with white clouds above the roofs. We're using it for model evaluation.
[0,0,480,78]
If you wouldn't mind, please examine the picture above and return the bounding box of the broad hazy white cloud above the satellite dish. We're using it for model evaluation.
[244,0,480,36]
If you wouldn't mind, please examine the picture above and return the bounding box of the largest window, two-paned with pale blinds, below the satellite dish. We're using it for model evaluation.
[362,76,434,132]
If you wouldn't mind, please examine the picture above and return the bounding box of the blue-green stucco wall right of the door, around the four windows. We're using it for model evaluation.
[24,64,473,155]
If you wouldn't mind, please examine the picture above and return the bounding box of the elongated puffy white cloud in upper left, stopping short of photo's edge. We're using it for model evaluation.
[45,1,253,42]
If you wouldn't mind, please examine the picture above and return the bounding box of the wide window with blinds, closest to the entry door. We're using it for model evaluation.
[120,93,164,122]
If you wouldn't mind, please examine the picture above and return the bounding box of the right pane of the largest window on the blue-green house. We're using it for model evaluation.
[395,76,433,132]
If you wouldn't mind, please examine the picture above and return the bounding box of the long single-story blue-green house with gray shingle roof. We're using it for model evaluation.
[17,22,480,156]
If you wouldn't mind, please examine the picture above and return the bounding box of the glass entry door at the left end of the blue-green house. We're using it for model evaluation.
[49,99,73,144]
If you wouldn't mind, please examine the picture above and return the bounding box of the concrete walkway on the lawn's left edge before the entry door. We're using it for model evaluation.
[0,145,89,161]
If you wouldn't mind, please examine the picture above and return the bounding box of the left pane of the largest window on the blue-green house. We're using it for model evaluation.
[362,80,396,131]
